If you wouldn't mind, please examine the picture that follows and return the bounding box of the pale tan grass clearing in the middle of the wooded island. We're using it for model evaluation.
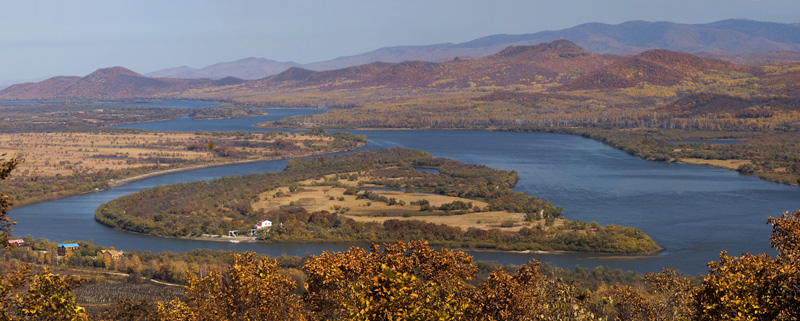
[252,176,563,232]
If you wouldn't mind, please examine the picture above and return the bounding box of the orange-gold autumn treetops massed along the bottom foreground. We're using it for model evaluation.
[90,211,800,320]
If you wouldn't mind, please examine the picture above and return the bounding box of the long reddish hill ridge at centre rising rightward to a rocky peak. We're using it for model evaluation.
[242,40,622,90]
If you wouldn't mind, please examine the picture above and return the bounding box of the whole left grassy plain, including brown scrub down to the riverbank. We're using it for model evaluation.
[0,130,366,206]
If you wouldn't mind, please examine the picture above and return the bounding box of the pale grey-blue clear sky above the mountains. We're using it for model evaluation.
[0,0,800,84]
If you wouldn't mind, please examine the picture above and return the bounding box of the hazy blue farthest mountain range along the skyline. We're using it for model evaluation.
[146,19,800,80]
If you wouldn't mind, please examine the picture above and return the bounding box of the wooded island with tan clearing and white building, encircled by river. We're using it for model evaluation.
[95,148,661,253]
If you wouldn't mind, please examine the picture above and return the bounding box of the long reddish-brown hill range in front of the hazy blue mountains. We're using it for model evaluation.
[0,40,764,100]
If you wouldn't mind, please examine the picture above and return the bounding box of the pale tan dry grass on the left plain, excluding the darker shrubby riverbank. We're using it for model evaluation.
[0,132,346,177]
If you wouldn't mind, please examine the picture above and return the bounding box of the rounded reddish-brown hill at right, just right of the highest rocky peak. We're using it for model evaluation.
[558,50,735,90]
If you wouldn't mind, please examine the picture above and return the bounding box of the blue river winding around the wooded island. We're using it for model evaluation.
[10,110,800,274]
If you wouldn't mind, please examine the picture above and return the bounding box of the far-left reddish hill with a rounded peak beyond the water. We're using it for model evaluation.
[0,67,219,100]
